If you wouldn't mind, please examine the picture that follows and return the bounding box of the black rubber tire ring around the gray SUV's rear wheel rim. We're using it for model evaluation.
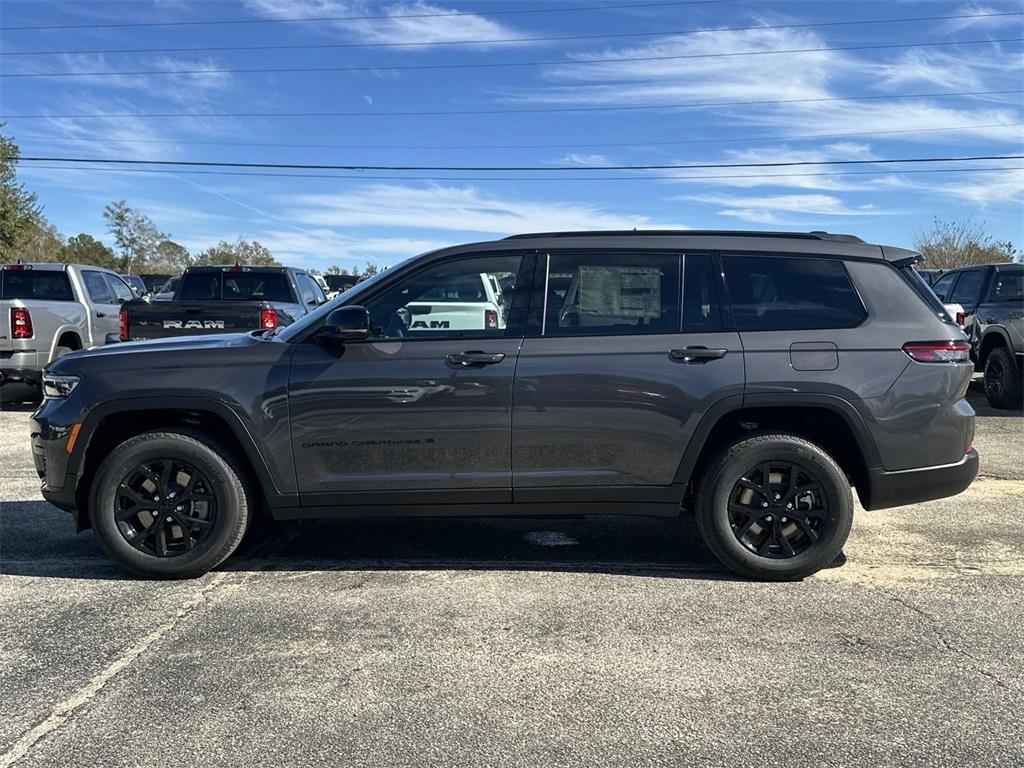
[707,439,853,579]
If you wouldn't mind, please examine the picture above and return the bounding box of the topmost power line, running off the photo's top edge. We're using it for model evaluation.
[0,0,739,32]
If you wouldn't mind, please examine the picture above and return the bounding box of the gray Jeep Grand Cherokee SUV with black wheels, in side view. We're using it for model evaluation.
[32,231,978,580]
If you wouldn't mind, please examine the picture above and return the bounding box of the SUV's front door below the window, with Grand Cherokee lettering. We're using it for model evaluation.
[290,339,521,504]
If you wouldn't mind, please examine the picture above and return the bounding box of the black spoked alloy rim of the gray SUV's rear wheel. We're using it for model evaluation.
[728,461,829,559]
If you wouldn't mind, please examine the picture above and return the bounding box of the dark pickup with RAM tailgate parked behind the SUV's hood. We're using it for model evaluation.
[120,266,327,341]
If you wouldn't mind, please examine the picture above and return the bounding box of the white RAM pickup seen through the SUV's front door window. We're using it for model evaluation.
[398,272,515,336]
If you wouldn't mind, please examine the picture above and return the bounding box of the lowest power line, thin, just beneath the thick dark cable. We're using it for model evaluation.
[19,165,1024,181]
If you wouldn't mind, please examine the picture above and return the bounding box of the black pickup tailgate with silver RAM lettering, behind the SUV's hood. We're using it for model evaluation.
[124,300,268,341]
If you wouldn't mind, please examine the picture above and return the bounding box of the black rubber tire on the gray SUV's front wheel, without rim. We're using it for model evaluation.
[89,431,253,579]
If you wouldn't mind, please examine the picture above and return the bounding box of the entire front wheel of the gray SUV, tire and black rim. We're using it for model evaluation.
[89,432,252,579]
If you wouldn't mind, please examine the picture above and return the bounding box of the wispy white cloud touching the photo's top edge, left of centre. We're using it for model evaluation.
[239,0,522,50]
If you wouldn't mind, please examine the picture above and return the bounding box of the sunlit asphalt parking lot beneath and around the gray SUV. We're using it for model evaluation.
[0,380,1024,768]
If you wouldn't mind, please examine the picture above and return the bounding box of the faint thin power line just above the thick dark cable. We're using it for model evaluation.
[19,123,1024,152]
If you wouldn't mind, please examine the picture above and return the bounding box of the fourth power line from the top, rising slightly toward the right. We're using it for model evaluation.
[0,88,1024,120]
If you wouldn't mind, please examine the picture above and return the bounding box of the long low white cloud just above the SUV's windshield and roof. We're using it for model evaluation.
[289,184,678,234]
